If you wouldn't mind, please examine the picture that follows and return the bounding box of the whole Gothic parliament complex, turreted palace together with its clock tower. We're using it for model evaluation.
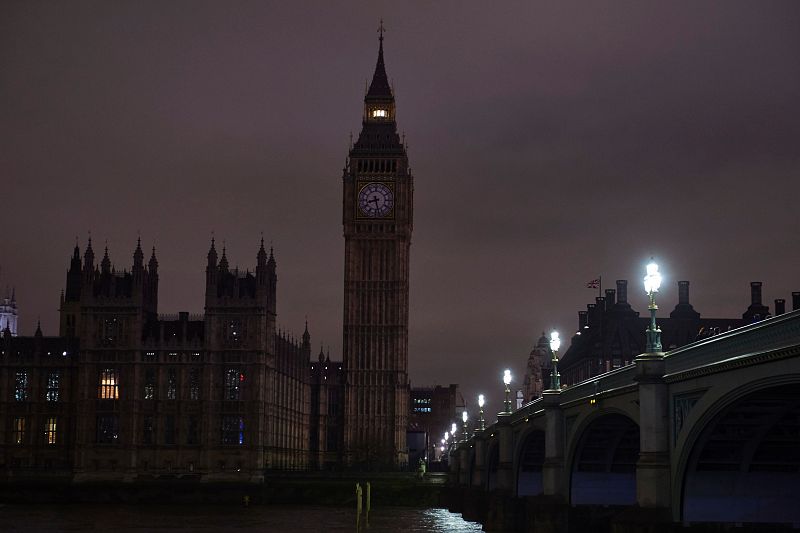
[0,32,413,483]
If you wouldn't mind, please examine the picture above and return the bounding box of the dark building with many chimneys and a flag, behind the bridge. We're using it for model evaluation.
[552,280,800,386]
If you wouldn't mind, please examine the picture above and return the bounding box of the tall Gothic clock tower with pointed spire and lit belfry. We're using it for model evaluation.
[342,25,414,468]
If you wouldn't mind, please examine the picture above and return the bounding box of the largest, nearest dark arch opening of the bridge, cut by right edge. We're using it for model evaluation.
[673,374,800,524]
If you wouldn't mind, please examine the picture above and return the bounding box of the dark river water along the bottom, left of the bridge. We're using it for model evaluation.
[0,504,481,533]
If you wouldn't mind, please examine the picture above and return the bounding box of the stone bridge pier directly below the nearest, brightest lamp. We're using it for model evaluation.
[634,352,672,509]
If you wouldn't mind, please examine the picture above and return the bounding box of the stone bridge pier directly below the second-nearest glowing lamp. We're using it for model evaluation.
[542,390,569,503]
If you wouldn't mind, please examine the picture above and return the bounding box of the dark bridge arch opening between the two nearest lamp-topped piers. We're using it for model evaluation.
[567,410,639,505]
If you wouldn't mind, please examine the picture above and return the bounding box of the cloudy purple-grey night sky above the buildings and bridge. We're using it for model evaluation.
[0,1,800,411]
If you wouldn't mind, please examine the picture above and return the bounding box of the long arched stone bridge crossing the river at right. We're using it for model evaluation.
[449,311,800,531]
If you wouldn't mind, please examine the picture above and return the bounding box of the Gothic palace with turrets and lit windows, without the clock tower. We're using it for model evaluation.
[0,240,332,482]
